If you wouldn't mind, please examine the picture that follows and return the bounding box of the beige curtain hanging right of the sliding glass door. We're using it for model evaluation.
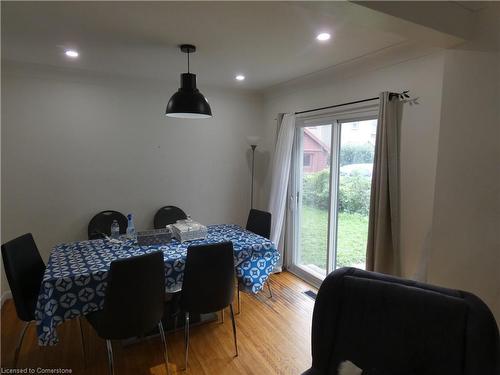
[366,92,401,275]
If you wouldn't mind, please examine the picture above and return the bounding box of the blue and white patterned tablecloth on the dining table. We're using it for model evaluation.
[35,225,279,345]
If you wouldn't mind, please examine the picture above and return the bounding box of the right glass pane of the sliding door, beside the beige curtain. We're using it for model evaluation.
[335,120,377,269]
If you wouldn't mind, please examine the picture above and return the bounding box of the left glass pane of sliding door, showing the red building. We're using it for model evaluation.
[296,124,332,277]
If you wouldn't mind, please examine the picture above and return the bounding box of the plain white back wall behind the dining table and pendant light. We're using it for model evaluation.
[1,64,262,291]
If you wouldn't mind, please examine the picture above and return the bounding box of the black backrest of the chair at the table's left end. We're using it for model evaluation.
[2,233,45,322]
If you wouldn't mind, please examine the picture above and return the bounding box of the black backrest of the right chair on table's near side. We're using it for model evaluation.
[180,242,235,313]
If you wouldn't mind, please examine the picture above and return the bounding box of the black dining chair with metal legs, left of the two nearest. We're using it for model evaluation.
[87,251,169,375]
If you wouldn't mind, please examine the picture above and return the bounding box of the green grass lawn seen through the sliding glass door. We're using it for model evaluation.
[300,206,368,269]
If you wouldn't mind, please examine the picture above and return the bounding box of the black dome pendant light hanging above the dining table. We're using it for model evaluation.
[165,44,212,119]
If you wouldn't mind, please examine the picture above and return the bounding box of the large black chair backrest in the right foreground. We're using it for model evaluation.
[305,268,500,375]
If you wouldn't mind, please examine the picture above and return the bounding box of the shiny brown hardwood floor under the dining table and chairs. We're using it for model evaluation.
[1,272,314,375]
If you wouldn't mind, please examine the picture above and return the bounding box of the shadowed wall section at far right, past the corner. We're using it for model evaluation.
[428,16,500,325]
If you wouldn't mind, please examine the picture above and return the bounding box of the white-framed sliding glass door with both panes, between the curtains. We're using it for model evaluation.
[288,116,377,284]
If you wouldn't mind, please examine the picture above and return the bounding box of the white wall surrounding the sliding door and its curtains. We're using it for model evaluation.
[261,53,443,277]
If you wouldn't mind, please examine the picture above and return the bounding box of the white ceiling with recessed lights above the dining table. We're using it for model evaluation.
[2,1,464,89]
